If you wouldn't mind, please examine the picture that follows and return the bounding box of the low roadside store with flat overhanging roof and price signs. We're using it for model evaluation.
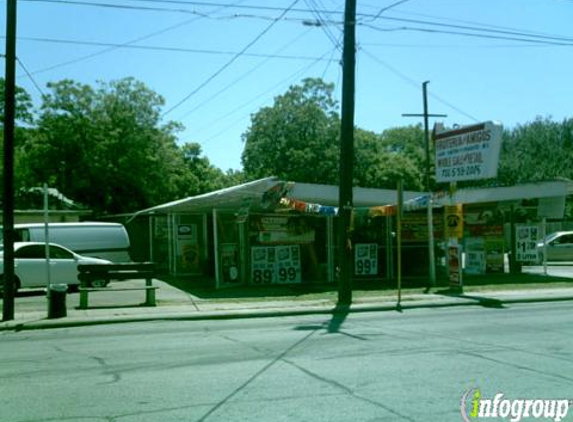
[126,177,573,288]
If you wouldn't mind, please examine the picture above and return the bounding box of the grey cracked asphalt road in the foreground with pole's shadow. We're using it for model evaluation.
[0,302,573,422]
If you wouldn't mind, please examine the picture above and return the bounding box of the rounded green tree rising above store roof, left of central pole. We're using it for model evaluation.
[242,79,340,183]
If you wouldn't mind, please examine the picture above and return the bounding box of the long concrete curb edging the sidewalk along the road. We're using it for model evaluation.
[0,295,573,332]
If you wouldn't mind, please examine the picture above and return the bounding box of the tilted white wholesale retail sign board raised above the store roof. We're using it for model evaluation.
[434,122,503,183]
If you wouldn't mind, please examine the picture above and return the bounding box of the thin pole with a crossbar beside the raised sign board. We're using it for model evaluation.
[402,81,447,292]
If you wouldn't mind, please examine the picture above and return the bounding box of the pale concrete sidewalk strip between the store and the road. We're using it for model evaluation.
[0,280,573,331]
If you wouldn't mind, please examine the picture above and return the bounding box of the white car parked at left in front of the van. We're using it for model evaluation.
[0,242,111,291]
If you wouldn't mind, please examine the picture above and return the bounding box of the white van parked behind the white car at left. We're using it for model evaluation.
[6,223,131,262]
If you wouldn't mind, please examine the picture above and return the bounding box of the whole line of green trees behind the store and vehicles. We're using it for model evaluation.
[0,78,573,213]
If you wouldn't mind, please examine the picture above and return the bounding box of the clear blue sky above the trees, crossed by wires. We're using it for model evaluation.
[0,0,573,170]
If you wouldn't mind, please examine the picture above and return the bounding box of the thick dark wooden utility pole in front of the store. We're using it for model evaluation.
[338,0,356,306]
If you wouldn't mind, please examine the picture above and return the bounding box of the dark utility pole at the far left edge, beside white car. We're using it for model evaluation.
[2,0,16,321]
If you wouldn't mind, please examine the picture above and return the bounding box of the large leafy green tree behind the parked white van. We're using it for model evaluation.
[22,78,182,213]
